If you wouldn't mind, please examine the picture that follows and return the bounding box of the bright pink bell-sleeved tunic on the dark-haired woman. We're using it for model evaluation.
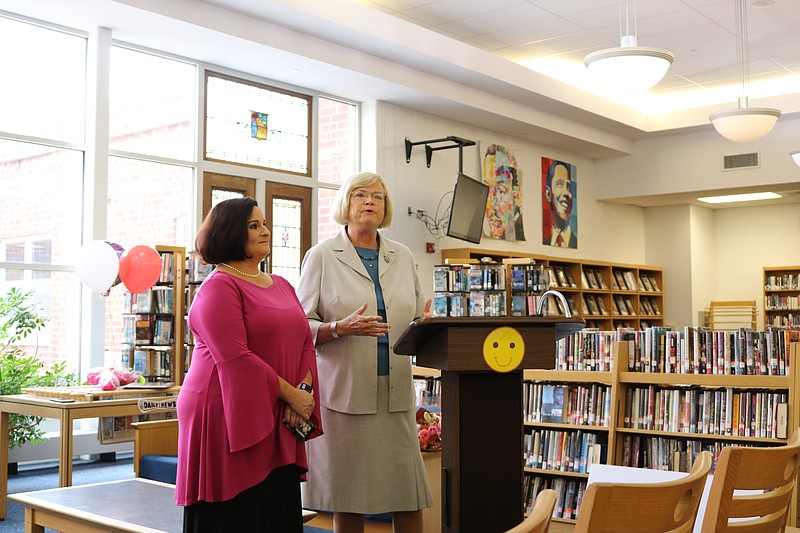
[175,272,322,506]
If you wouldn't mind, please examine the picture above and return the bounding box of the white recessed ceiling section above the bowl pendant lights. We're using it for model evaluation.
[355,0,800,109]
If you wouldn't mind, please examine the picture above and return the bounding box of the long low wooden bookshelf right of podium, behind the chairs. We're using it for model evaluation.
[523,328,800,525]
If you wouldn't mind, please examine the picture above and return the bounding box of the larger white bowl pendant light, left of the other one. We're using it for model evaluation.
[583,0,675,92]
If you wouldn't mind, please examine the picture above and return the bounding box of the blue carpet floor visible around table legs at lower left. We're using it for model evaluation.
[0,454,330,533]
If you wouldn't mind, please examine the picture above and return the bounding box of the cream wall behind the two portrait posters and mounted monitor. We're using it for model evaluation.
[372,98,645,295]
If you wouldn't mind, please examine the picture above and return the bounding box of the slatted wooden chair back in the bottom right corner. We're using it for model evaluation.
[703,429,800,533]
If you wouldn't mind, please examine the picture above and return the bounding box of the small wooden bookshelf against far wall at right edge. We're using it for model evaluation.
[764,266,800,328]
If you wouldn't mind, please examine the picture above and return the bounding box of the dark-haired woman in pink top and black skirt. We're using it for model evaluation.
[175,198,322,533]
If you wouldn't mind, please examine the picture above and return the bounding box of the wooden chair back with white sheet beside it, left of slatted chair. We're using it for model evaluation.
[575,452,713,533]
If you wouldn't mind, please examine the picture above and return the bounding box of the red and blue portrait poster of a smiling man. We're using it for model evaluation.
[542,157,578,248]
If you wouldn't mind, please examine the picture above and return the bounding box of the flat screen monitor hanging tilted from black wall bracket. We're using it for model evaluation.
[447,172,489,244]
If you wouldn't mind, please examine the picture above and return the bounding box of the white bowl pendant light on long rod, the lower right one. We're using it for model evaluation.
[708,0,781,143]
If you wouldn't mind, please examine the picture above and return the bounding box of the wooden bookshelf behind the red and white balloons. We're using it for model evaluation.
[122,245,186,385]
